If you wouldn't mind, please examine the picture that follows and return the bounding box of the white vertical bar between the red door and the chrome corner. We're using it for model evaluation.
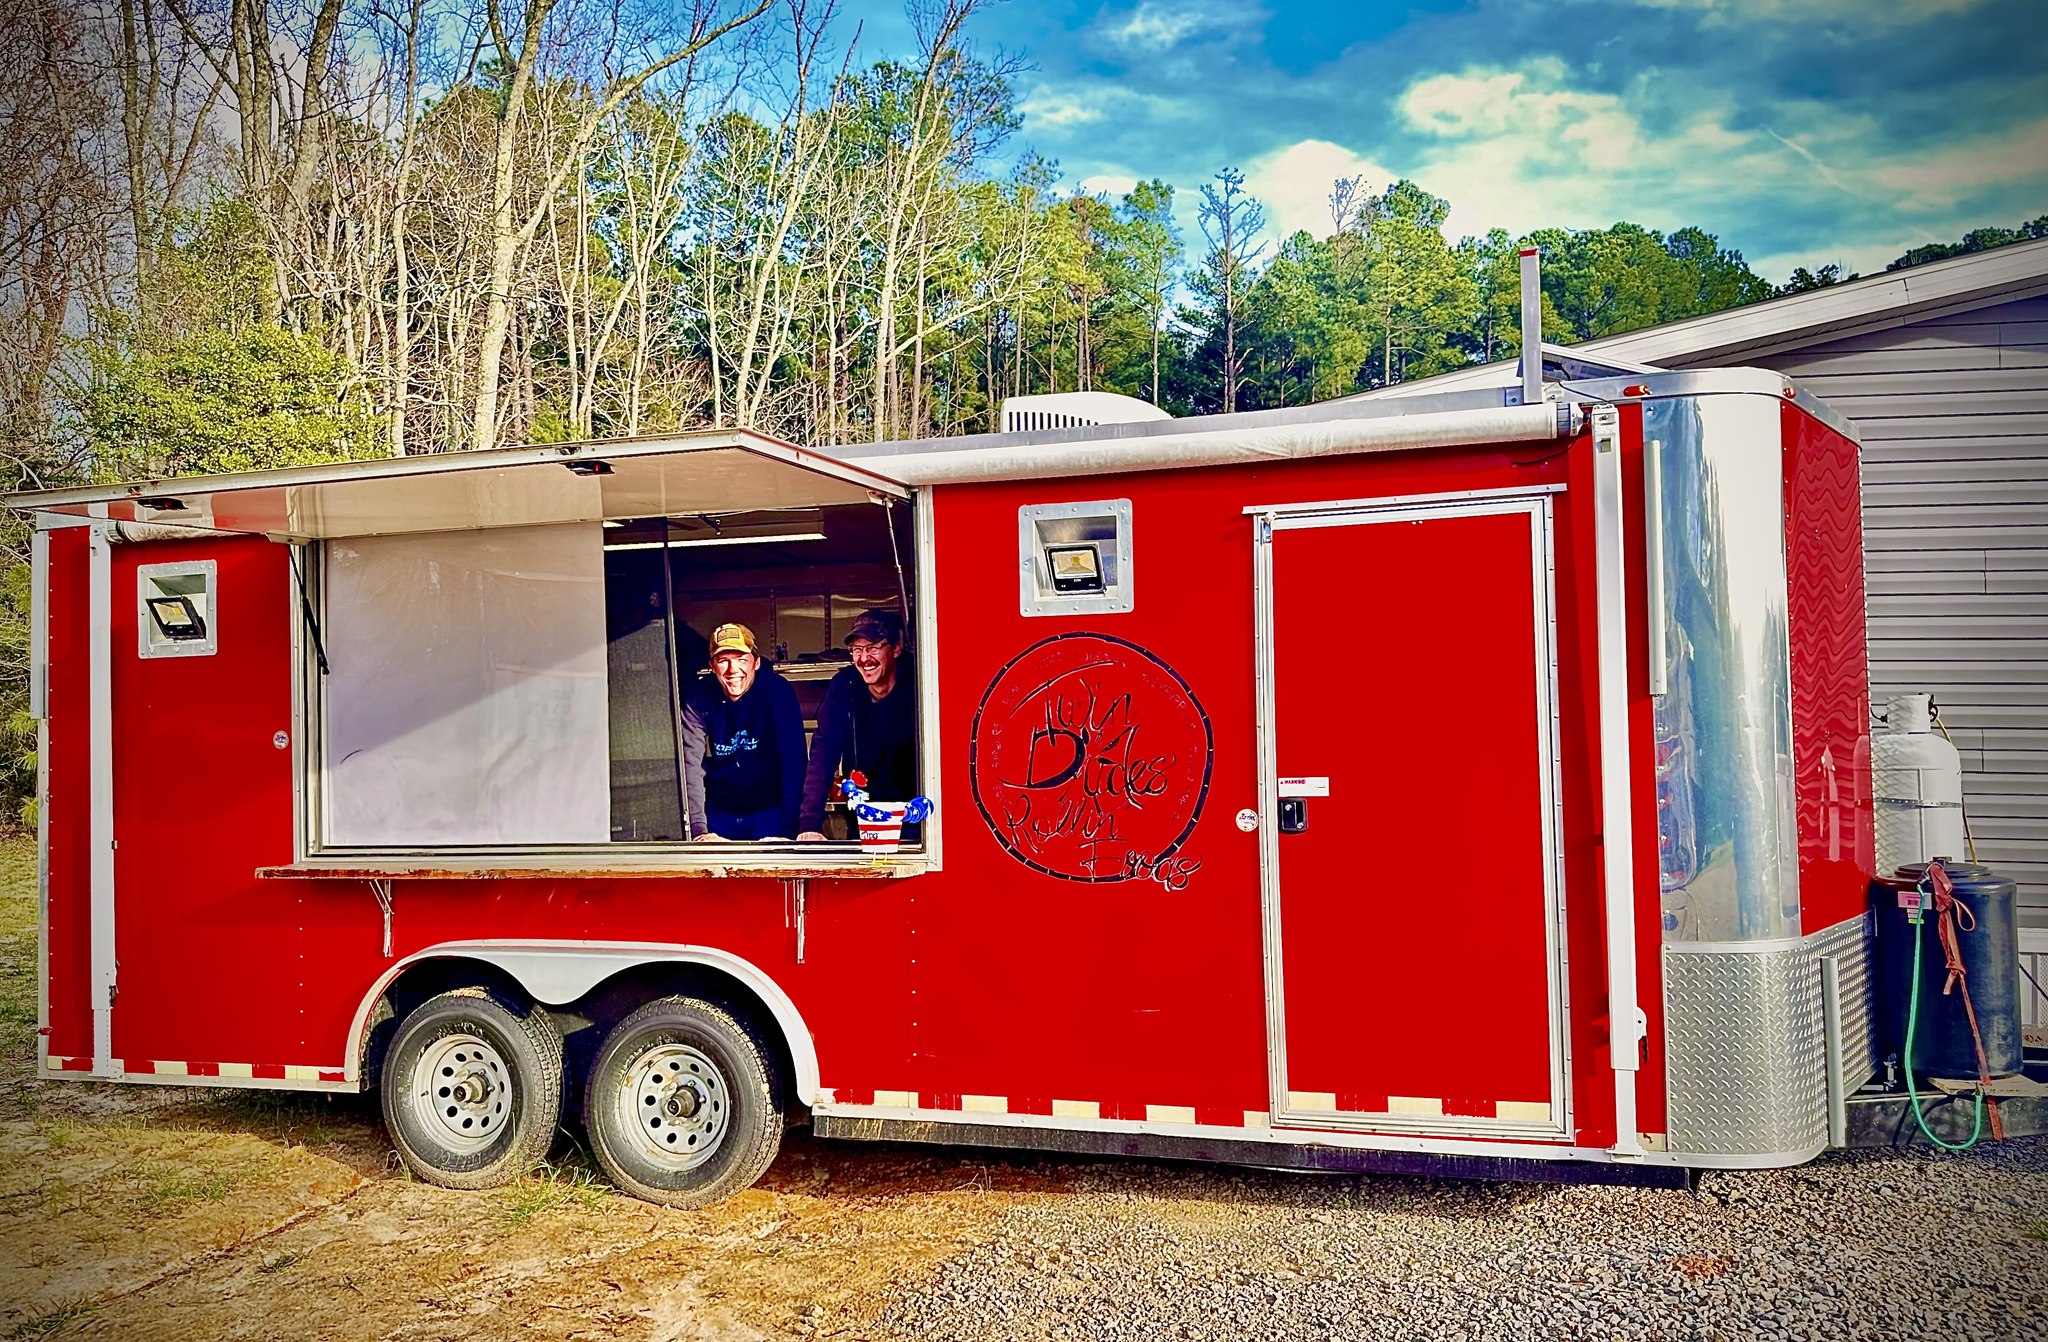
[1589,406,1645,1158]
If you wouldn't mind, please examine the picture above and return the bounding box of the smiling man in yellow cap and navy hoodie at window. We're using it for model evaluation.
[682,625,805,840]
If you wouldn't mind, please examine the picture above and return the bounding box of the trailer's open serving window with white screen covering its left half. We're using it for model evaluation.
[305,502,922,858]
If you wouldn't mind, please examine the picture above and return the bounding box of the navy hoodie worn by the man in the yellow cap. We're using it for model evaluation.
[682,666,805,838]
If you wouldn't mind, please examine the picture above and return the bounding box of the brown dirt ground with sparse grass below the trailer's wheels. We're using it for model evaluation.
[0,1119,1057,1340]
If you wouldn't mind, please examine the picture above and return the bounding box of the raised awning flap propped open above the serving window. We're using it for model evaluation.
[0,430,909,541]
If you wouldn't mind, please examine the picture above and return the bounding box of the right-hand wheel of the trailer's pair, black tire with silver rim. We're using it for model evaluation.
[584,998,782,1207]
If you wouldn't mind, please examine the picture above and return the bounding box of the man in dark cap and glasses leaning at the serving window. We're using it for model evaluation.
[797,611,918,842]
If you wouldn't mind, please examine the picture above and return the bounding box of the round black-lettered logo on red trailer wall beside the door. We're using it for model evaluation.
[969,633,1217,889]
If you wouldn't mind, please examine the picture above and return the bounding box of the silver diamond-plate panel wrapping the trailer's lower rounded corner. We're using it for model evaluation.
[1665,942,1827,1160]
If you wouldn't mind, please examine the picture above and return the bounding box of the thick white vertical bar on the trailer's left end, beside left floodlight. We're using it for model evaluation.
[86,504,121,1076]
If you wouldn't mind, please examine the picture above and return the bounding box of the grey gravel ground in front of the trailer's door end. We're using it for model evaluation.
[879,1137,2048,1342]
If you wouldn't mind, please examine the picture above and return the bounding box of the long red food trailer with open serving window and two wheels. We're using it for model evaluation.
[8,360,1957,1205]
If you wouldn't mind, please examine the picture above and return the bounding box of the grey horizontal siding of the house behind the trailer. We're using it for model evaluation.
[1757,297,2048,922]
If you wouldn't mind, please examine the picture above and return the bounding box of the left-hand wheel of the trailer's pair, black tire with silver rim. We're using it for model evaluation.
[381,988,561,1188]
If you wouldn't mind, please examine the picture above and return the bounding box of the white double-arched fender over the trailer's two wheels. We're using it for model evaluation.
[346,940,819,1104]
